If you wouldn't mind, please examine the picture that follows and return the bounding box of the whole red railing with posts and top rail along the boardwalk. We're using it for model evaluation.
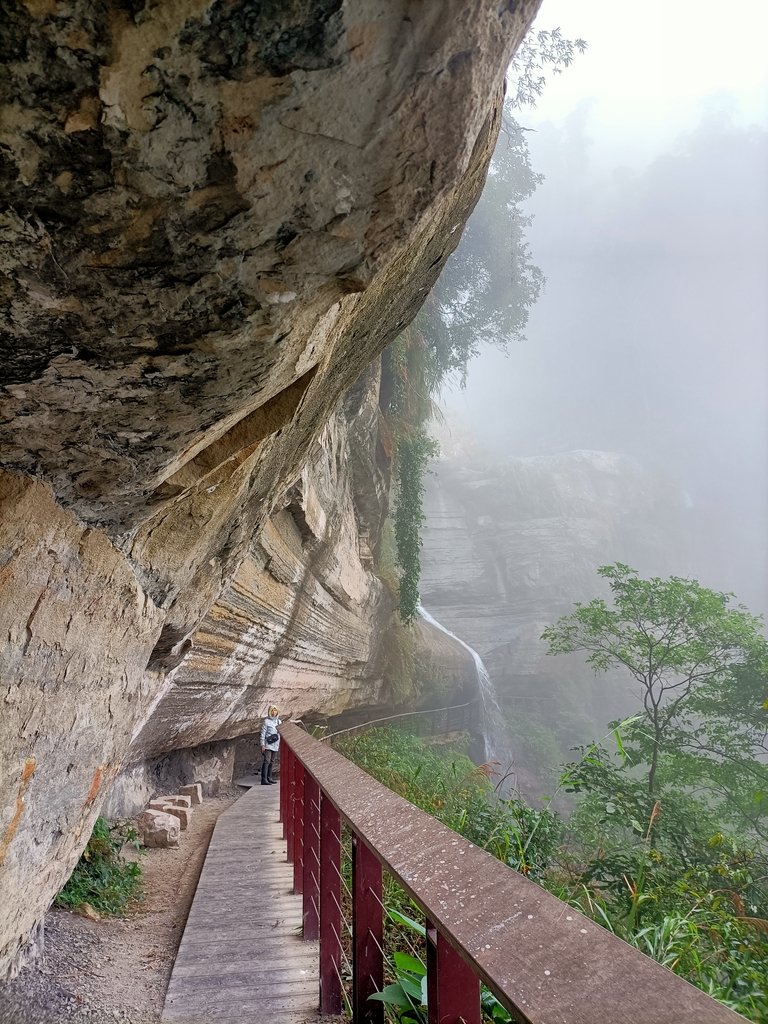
[280,724,743,1024]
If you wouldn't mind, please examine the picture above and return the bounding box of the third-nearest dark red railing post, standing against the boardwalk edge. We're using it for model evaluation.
[321,794,342,1017]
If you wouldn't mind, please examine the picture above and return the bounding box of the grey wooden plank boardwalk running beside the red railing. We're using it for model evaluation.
[162,785,319,1024]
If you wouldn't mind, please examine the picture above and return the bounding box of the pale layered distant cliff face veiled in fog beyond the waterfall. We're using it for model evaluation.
[422,452,687,769]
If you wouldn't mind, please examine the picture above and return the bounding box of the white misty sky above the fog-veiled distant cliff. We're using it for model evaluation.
[447,0,768,611]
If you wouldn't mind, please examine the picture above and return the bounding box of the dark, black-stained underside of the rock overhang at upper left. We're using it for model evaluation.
[0,0,536,532]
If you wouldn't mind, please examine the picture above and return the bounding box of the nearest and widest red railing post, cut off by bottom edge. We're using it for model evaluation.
[427,922,480,1024]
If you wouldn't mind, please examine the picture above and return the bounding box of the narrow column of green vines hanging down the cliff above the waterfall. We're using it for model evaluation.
[394,431,437,623]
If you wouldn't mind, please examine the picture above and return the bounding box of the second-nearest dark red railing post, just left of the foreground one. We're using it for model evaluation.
[352,836,384,1024]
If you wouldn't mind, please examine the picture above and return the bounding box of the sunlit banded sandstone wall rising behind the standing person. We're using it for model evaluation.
[131,369,393,759]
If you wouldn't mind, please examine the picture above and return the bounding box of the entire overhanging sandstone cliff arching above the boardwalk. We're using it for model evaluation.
[0,0,538,976]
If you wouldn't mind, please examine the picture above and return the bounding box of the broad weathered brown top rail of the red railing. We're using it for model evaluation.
[281,723,743,1024]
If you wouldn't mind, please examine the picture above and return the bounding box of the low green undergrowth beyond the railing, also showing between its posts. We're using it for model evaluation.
[338,715,768,1024]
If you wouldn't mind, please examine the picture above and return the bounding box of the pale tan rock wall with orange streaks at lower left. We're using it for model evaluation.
[0,473,162,970]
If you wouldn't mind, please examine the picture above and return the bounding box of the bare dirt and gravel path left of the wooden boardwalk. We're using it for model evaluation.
[0,791,242,1024]
